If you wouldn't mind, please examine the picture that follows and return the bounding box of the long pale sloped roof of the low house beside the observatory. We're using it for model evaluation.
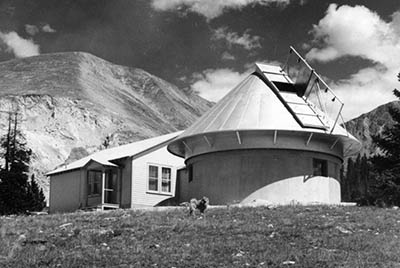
[46,131,182,176]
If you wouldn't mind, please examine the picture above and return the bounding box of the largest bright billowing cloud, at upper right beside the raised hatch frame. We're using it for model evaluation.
[306,4,400,119]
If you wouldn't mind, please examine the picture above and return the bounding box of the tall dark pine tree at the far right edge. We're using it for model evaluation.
[372,87,400,205]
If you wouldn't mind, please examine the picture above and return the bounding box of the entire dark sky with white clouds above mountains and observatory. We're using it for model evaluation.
[0,0,400,120]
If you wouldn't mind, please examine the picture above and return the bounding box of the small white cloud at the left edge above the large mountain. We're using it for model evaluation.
[0,32,39,58]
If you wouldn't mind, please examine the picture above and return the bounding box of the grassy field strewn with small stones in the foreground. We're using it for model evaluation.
[0,206,400,267]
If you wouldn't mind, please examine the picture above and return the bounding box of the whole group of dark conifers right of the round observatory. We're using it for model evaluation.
[341,78,400,206]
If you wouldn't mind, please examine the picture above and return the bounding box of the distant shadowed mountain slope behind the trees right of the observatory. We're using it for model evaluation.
[345,101,400,156]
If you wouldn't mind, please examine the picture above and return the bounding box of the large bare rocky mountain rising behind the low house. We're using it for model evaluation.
[0,52,211,199]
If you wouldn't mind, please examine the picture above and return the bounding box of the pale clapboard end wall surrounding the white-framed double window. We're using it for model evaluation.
[131,146,184,207]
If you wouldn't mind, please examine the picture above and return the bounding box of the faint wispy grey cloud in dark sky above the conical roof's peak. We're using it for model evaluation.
[212,27,261,50]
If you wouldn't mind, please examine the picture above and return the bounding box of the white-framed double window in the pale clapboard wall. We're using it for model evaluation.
[148,165,172,193]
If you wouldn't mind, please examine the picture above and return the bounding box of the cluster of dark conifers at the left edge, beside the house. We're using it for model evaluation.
[0,112,46,215]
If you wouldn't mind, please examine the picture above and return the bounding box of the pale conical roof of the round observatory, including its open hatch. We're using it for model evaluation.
[168,64,359,156]
